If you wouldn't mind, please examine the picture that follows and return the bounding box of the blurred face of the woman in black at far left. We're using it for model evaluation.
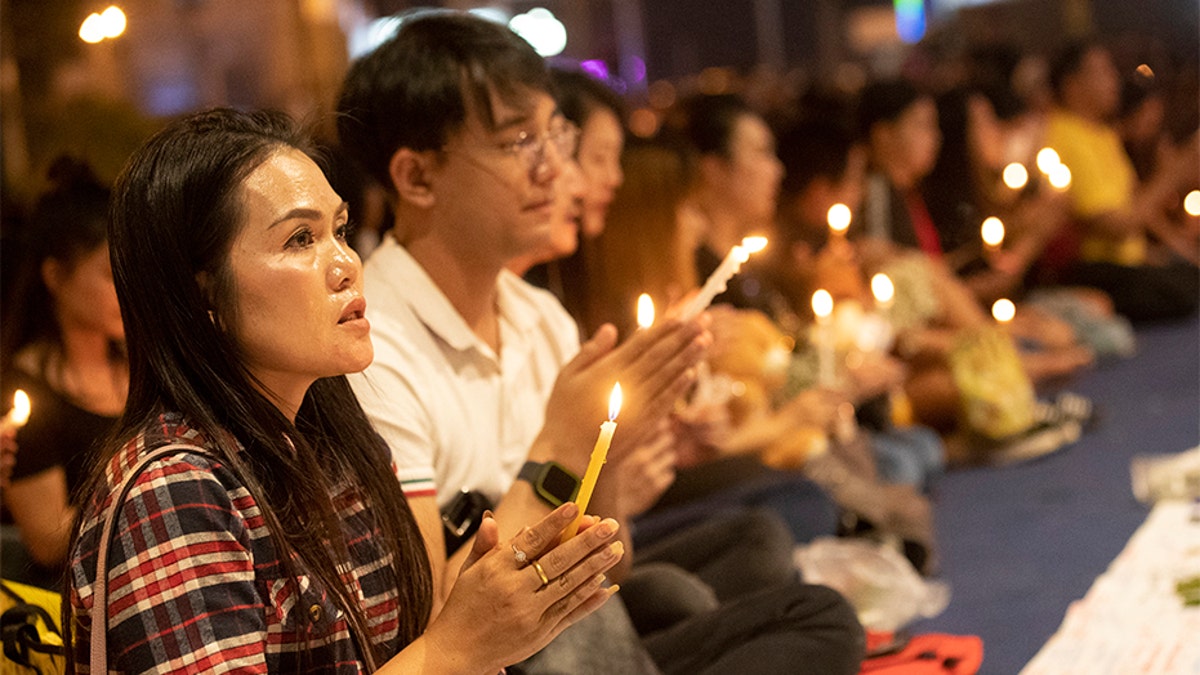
[43,243,125,340]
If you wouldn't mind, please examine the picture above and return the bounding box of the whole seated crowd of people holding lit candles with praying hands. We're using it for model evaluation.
[0,7,1200,674]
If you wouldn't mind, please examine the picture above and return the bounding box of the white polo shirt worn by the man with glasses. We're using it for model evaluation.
[350,238,580,506]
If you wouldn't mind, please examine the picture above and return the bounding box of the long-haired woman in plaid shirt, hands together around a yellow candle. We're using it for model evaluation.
[64,109,620,673]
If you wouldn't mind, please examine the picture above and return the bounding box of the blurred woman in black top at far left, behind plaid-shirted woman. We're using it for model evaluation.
[0,156,128,589]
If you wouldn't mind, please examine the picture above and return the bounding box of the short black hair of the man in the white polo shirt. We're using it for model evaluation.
[337,11,551,192]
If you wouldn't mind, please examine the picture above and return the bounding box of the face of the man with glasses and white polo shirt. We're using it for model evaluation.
[431,90,576,267]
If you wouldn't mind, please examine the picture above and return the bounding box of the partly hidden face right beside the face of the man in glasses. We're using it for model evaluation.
[578,108,625,239]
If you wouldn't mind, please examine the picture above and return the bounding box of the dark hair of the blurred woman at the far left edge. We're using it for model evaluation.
[0,155,109,372]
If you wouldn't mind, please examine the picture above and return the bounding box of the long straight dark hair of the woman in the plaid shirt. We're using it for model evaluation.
[64,109,432,657]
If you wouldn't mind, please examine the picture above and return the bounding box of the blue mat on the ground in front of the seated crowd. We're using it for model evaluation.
[912,318,1200,675]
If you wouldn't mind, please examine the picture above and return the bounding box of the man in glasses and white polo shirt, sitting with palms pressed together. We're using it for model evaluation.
[338,12,862,673]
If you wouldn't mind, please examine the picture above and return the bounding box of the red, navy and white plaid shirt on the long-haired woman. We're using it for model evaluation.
[68,416,403,673]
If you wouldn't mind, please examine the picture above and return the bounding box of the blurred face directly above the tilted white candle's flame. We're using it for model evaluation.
[719,115,784,227]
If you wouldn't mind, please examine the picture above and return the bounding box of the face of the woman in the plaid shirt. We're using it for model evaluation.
[225,148,374,412]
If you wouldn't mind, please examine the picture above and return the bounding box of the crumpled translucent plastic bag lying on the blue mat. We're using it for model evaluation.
[796,537,950,631]
